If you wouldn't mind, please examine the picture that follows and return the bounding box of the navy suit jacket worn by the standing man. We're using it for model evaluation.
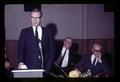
[18,26,54,70]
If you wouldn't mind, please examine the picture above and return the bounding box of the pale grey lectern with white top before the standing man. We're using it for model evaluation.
[12,69,45,78]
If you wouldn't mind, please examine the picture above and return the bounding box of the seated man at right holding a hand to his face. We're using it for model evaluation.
[69,43,111,77]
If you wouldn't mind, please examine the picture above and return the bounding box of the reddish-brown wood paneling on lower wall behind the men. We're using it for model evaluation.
[6,39,114,68]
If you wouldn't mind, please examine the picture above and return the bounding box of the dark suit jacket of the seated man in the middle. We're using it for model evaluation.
[54,41,80,74]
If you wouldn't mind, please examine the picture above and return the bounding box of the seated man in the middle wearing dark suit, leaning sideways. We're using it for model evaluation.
[53,37,80,77]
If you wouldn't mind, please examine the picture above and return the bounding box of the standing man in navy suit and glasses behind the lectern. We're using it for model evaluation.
[18,9,54,74]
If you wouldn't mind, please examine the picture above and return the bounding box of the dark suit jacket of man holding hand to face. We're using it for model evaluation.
[76,55,111,76]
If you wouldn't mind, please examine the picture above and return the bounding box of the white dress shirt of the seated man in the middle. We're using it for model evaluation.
[61,47,69,67]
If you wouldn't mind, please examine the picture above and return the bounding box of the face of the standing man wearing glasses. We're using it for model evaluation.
[31,12,41,27]
